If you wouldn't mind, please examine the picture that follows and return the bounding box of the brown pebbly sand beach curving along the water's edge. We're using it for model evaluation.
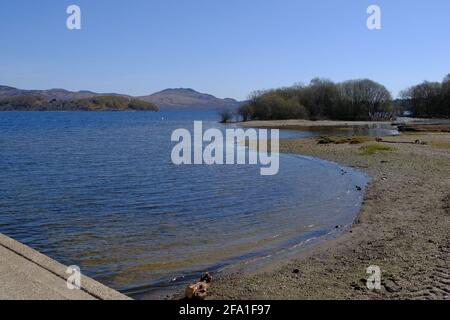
[210,131,450,299]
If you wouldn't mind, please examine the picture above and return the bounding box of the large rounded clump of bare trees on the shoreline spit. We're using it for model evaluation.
[238,78,392,121]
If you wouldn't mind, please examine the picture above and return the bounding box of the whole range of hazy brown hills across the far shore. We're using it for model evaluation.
[0,86,241,111]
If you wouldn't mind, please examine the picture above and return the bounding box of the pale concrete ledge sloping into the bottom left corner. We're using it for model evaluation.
[0,233,130,300]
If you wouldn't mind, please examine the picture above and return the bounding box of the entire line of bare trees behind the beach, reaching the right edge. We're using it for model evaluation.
[237,75,450,121]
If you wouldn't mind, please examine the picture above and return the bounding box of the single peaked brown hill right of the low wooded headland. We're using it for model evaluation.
[139,88,241,111]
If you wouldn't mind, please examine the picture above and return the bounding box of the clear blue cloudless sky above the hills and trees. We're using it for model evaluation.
[0,0,450,99]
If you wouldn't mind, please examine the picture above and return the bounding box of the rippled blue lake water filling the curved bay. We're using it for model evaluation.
[0,113,367,297]
